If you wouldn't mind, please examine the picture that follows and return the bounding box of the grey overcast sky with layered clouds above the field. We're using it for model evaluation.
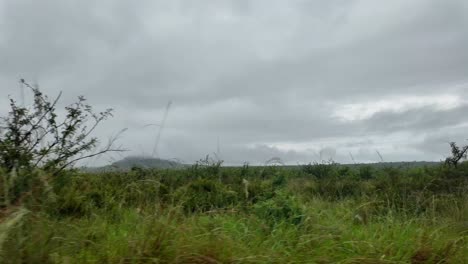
[0,0,468,164]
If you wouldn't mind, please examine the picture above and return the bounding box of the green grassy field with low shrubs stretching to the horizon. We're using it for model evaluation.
[0,162,468,263]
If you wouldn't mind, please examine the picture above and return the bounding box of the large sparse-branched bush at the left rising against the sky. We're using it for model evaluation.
[0,79,122,207]
